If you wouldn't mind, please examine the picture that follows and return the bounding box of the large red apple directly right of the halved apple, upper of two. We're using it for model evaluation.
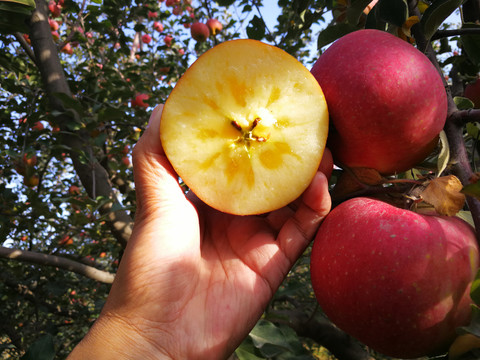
[311,29,447,174]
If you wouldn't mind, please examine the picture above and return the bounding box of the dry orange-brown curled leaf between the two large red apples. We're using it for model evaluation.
[421,175,465,216]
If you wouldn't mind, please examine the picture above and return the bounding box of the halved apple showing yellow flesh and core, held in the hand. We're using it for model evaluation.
[160,40,328,215]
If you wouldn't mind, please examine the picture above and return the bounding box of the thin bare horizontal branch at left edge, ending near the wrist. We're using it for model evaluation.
[0,246,115,284]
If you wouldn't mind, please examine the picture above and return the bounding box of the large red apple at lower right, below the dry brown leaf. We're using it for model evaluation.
[310,198,479,358]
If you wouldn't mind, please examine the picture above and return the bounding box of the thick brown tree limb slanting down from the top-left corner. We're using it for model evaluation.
[30,0,133,246]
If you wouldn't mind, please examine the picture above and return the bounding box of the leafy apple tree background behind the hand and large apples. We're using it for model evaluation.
[0,0,480,359]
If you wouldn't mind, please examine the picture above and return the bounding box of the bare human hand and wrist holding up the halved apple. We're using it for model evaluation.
[69,106,333,360]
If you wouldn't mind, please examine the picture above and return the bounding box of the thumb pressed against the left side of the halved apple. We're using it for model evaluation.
[132,105,186,221]
